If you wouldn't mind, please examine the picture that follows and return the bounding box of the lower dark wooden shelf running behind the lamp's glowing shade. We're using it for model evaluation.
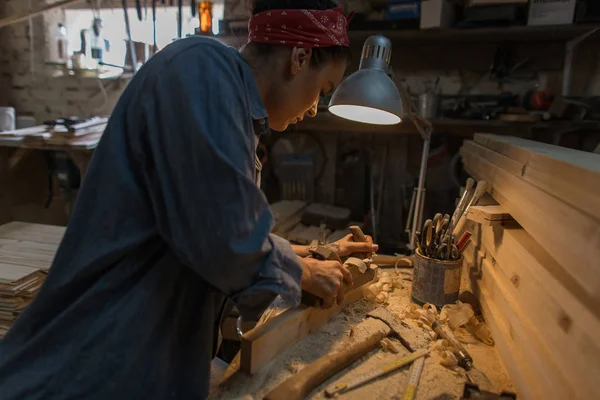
[290,111,600,137]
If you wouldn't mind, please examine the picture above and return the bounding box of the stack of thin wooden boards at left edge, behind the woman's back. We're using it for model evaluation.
[0,222,65,339]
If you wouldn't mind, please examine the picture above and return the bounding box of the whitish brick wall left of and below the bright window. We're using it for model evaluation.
[0,0,127,123]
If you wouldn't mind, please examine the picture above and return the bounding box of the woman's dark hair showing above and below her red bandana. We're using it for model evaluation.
[251,0,352,68]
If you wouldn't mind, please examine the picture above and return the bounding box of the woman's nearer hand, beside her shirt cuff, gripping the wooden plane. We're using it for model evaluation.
[300,257,352,308]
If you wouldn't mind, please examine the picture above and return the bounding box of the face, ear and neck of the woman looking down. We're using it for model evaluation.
[265,48,346,131]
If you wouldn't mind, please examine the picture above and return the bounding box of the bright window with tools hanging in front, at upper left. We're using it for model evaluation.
[65,4,224,66]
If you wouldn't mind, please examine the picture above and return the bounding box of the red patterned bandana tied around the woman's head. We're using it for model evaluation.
[248,7,354,48]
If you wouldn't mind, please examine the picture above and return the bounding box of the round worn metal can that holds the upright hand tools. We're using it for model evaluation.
[411,249,463,308]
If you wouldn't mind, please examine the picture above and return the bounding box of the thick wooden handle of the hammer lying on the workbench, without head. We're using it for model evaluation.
[264,329,391,400]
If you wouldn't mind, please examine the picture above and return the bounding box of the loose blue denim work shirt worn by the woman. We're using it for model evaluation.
[0,37,302,400]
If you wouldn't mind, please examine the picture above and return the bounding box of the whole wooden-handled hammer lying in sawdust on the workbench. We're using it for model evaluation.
[264,307,428,400]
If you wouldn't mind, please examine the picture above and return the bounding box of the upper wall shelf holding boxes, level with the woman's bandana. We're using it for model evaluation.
[216,23,600,45]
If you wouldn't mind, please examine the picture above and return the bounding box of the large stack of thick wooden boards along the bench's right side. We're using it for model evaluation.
[461,135,600,399]
